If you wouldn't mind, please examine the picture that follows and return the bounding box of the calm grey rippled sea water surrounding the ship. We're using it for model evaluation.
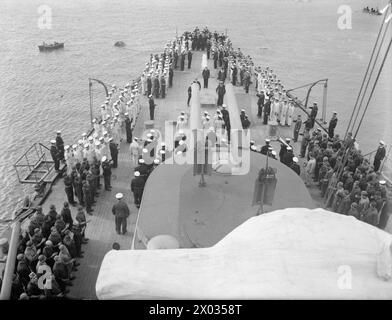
[0,0,392,232]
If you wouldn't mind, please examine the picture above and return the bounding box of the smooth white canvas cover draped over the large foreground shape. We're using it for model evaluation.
[96,208,392,299]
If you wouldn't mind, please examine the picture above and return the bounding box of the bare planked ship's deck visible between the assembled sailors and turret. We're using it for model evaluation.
[31,52,317,299]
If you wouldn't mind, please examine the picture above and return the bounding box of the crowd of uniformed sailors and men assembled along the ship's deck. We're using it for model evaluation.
[3,27,386,299]
